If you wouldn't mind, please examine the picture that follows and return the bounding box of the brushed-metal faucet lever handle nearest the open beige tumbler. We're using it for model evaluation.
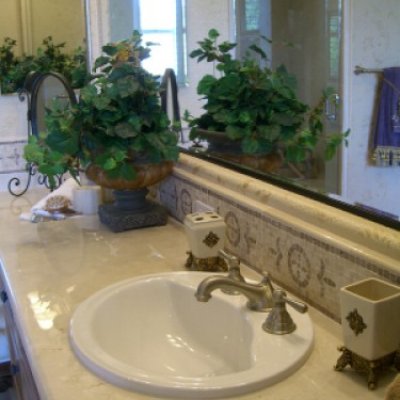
[262,289,308,335]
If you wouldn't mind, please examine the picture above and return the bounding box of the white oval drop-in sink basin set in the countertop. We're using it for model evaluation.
[70,272,314,399]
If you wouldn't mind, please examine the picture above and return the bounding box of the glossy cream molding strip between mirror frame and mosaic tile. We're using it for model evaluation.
[174,154,400,275]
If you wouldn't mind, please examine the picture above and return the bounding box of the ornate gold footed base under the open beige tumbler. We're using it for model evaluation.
[334,346,400,390]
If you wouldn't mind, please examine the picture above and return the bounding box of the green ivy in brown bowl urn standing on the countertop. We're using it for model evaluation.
[25,31,179,230]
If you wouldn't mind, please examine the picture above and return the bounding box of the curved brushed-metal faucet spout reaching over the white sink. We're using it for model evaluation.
[195,275,273,311]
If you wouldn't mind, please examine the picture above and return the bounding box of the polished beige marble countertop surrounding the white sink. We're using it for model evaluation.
[0,191,394,400]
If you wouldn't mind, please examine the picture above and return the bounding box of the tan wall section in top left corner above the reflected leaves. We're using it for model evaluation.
[0,0,85,53]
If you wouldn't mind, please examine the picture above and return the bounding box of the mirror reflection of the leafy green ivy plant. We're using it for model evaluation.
[184,29,349,170]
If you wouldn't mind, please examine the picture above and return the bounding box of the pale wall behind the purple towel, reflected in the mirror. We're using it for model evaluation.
[344,0,400,215]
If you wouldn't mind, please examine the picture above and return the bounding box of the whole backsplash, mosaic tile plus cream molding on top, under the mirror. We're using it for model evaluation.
[160,156,400,320]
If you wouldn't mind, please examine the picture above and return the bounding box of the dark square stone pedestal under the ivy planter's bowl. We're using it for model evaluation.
[99,188,168,232]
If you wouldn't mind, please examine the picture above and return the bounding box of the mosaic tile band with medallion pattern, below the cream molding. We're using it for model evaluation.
[159,175,400,320]
